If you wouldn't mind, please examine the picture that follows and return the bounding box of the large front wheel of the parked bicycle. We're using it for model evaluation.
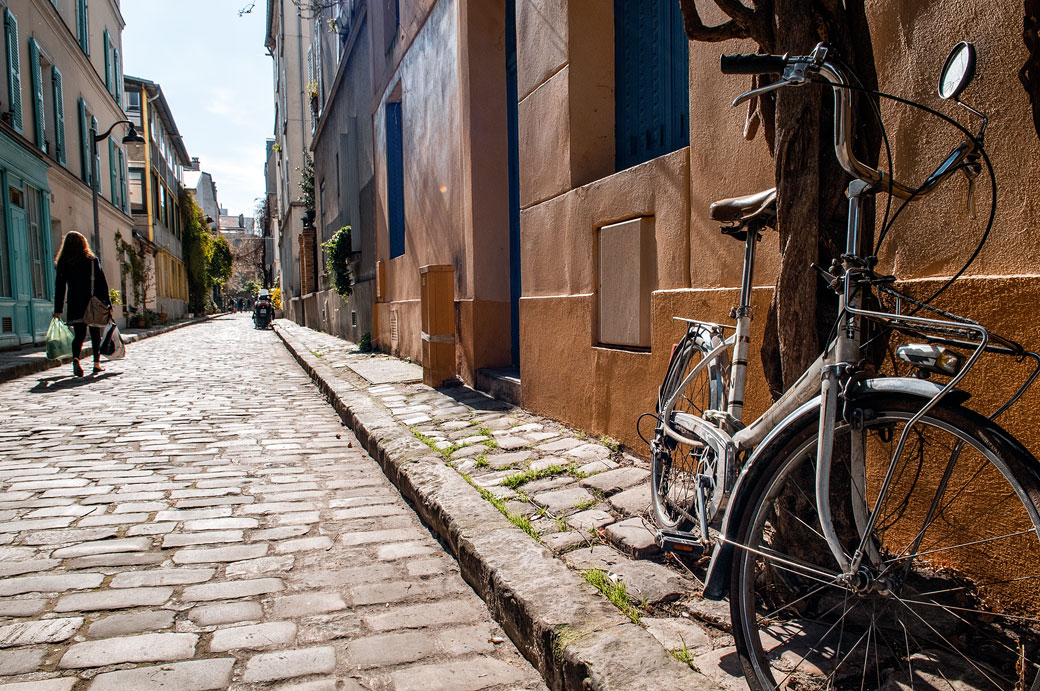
[730,396,1040,690]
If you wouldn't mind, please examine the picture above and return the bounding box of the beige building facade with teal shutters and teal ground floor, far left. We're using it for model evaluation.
[0,0,131,348]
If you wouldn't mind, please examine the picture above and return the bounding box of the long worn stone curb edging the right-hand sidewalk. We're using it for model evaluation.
[275,323,720,691]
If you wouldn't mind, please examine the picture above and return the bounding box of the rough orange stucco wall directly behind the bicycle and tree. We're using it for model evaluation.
[517,0,1040,453]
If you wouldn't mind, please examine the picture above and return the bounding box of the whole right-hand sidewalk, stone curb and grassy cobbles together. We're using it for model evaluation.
[276,319,746,691]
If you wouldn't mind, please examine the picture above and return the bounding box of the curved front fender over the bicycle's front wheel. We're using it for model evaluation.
[704,377,970,599]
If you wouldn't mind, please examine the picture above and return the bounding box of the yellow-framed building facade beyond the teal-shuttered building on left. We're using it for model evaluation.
[125,76,192,318]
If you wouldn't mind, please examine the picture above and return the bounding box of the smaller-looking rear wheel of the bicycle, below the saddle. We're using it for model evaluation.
[650,329,729,532]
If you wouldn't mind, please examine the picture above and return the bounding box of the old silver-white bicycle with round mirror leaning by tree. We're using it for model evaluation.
[650,42,1040,691]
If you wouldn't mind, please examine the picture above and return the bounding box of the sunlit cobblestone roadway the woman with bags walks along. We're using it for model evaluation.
[0,315,545,691]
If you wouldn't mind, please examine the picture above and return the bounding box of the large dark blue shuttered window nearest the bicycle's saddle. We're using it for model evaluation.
[614,0,690,171]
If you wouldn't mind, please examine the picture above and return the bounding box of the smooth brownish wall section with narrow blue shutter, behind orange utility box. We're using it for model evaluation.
[373,0,511,383]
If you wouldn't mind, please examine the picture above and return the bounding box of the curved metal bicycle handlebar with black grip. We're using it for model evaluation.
[719,44,976,199]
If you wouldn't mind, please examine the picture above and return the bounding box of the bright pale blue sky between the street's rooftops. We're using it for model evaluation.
[120,0,275,215]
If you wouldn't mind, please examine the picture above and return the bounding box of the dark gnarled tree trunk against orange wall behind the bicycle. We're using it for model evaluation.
[761,0,880,399]
